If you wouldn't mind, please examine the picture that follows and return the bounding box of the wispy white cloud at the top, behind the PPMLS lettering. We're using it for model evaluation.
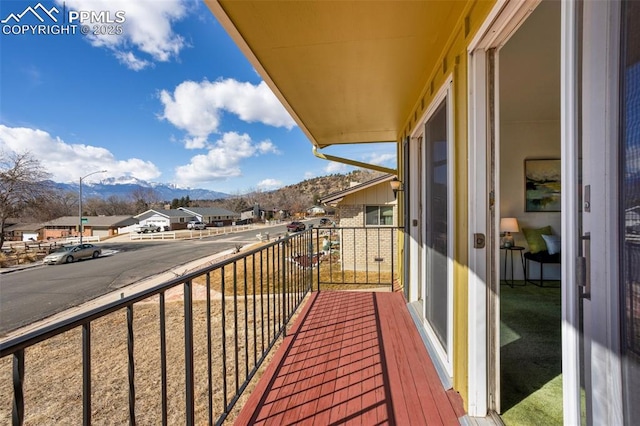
[56,0,188,71]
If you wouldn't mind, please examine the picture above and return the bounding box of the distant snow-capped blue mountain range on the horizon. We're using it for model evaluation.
[52,177,229,201]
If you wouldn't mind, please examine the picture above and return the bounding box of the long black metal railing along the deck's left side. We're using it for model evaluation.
[0,230,314,425]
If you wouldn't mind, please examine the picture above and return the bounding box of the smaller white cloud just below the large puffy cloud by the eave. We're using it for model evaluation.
[176,132,277,186]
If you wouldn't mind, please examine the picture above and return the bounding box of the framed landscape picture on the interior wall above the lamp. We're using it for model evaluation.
[524,159,561,212]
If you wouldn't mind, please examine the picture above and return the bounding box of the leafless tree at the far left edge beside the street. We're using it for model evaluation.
[0,152,50,247]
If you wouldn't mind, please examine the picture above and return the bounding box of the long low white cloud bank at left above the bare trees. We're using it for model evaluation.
[0,125,160,182]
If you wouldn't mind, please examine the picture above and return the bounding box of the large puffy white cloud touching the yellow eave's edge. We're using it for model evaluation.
[160,79,295,149]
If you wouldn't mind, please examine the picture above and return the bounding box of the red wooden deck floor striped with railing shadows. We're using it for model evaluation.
[235,292,464,425]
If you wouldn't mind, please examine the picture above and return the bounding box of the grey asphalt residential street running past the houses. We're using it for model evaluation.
[0,223,308,336]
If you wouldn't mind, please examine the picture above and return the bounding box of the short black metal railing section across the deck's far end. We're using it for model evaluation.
[314,226,398,290]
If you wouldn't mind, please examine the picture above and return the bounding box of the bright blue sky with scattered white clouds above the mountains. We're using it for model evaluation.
[0,0,395,194]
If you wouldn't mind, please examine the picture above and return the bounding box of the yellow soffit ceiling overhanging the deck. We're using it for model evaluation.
[205,0,470,148]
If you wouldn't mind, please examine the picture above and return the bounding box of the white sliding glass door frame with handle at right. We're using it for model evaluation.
[561,0,624,425]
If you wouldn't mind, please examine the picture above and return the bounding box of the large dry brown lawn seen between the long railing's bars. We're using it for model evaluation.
[0,290,308,425]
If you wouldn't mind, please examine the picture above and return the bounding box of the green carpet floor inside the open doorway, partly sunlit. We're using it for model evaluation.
[500,282,562,426]
